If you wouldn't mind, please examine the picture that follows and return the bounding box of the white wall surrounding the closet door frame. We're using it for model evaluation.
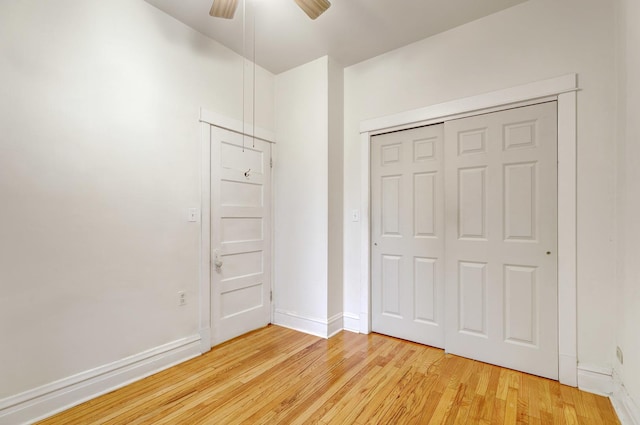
[345,0,616,368]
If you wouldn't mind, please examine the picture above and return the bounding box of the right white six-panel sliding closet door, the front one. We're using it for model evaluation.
[445,102,558,379]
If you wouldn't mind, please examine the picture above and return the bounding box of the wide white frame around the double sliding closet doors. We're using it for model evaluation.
[360,74,579,387]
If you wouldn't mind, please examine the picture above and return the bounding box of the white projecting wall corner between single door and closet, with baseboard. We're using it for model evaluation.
[274,56,344,337]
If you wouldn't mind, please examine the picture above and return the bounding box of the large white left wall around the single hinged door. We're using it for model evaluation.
[0,0,274,401]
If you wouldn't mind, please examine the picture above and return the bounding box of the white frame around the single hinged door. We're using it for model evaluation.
[198,108,276,353]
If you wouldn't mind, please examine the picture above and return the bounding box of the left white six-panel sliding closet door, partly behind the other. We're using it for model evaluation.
[371,125,445,347]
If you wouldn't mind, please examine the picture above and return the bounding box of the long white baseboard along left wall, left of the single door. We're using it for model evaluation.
[0,335,200,425]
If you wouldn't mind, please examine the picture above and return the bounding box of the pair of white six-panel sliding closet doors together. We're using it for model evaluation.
[371,102,558,379]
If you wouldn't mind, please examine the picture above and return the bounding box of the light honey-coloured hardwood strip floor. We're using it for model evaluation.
[41,326,619,425]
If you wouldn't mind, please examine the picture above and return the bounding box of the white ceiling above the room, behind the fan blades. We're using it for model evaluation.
[146,0,526,74]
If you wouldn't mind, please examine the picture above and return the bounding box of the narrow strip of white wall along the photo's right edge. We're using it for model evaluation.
[615,0,640,419]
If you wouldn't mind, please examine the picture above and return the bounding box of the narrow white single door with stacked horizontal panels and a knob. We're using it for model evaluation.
[211,126,271,345]
